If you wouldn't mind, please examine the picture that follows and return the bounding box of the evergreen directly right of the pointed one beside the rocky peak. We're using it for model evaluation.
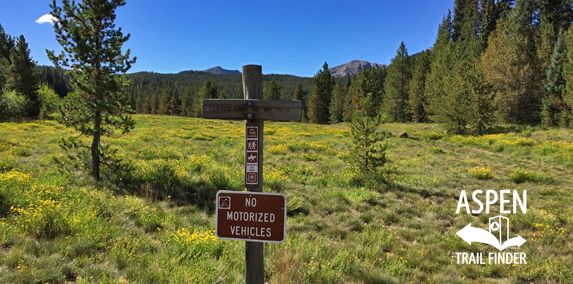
[408,51,430,123]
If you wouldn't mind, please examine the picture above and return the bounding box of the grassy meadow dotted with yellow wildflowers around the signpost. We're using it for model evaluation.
[0,115,573,284]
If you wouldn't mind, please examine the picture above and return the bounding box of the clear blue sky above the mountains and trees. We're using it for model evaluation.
[0,0,453,77]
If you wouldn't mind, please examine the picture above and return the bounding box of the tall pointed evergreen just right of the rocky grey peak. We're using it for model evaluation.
[384,42,411,122]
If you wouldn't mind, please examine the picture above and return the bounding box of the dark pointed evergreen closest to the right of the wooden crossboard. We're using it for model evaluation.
[308,62,334,124]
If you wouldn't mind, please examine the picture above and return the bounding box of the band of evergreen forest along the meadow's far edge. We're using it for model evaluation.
[8,0,573,134]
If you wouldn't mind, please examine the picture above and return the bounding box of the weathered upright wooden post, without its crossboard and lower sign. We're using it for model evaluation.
[243,65,265,284]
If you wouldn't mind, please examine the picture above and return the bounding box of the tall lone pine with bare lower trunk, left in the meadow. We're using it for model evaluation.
[47,0,136,181]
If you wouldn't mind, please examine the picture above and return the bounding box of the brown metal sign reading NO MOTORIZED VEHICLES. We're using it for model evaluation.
[215,190,287,243]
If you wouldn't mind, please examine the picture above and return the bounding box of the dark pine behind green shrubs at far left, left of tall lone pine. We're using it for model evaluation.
[10,35,41,117]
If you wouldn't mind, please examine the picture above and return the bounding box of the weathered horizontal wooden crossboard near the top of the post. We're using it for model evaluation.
[201,100,302,121]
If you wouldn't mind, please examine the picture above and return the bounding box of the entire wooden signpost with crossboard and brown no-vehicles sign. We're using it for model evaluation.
[201,65,302,284]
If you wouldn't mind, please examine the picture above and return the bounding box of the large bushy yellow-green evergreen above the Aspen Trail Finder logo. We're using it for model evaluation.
[482,0,541,124]
